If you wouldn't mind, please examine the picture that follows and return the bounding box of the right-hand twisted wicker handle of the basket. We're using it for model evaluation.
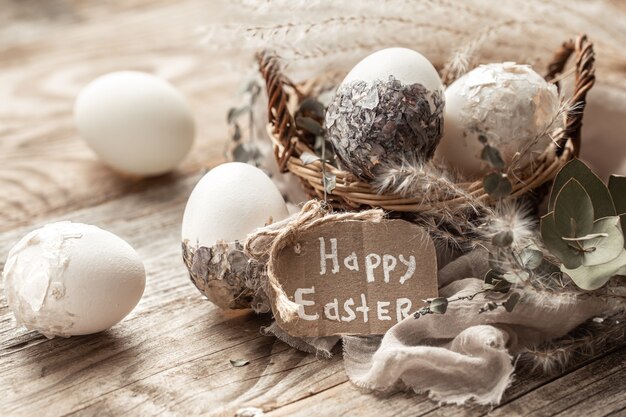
[545,34,596,157]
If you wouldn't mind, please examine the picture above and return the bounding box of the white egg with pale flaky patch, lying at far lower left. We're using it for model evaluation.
[3,222,145,337]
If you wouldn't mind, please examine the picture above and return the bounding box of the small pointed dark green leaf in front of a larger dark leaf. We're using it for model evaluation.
[554,178,594,237]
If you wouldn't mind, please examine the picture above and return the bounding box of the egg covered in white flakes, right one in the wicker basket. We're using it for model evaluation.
[435,62,562,179]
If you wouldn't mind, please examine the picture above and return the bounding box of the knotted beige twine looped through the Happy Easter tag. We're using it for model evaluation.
[244,200,385,323]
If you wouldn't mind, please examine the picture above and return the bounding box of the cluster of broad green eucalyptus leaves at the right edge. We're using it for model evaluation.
[541,159,626,290]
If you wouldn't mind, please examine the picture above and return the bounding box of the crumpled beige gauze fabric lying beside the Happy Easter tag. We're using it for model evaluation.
[343,252,624,404]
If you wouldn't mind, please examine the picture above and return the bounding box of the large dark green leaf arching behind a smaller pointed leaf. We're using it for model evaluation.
[548,158,621,220]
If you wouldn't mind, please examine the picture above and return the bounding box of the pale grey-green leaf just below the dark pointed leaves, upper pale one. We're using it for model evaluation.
[576,216,624,266]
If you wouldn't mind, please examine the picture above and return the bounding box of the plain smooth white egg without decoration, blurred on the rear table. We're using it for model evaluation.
[74,71,195,176]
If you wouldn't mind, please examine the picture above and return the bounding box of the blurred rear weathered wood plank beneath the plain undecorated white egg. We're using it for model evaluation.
[0,1,244,231]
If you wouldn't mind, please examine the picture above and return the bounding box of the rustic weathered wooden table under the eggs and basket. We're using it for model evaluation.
[0,0,626,417]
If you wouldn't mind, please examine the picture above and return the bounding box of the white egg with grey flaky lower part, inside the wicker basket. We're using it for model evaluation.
[325,48,444,180]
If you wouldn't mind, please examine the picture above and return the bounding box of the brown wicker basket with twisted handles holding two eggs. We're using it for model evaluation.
[258,35,595,213]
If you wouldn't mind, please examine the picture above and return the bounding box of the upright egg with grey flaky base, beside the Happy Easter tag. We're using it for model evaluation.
[182,162,289,308]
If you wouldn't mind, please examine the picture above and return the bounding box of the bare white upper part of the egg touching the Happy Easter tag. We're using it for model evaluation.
[182,162,288,247]
